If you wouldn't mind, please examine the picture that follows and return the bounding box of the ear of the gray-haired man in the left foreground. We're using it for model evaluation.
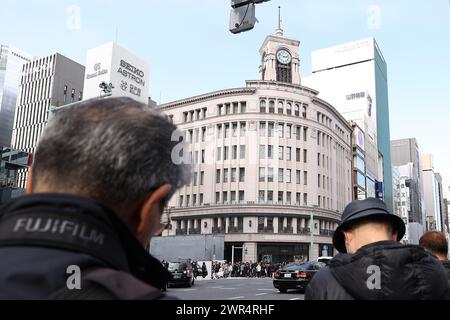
[137,184,172,246]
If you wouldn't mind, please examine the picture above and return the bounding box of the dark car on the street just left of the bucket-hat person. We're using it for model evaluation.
[273,261,326,293]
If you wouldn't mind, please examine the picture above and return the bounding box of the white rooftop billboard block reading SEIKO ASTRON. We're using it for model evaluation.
[84,42,149,103]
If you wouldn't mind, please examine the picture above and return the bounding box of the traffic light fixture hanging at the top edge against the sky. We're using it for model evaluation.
[230,0,270,33]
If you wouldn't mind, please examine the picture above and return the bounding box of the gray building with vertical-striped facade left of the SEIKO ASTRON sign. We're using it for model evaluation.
[11,53,84,188]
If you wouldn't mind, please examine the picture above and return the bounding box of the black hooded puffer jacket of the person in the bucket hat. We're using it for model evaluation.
[305,241,450,300]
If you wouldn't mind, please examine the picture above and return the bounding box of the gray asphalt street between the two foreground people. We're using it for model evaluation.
[167,278,304,301]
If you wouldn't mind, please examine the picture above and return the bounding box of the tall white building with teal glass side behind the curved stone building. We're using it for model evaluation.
[303,38,393,211]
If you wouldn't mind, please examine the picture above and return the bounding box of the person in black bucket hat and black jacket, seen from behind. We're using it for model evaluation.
[305,198,450,300]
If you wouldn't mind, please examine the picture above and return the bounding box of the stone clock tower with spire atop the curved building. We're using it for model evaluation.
[259,7,300,85]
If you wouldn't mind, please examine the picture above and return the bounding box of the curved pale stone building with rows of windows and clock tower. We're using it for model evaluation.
[159,30,352,262]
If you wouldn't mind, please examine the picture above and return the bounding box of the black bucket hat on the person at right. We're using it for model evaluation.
[333,198,406,253]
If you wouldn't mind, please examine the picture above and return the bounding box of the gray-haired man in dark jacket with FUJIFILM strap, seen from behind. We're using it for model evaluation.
[0,98,190,299]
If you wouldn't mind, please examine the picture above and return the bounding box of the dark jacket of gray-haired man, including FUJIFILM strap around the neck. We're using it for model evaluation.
[0,194,170,299]
